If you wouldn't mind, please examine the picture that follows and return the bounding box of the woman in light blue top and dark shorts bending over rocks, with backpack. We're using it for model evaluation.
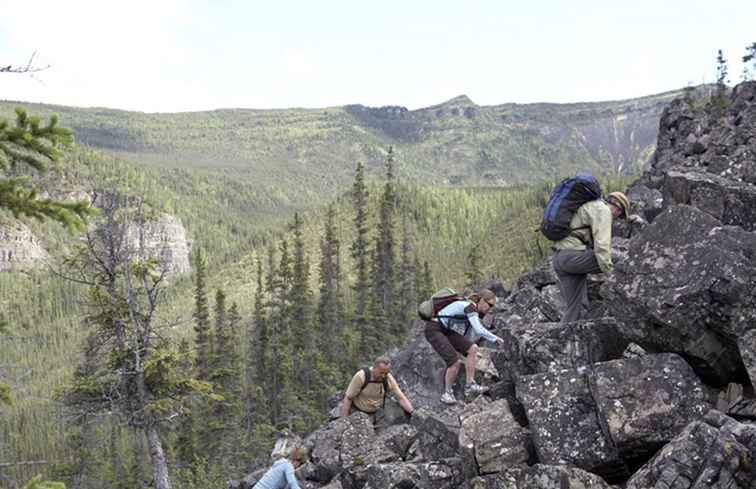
[418,289,502,404]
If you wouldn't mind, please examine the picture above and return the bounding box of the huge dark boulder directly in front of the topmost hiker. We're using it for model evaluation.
[592,205,756,385]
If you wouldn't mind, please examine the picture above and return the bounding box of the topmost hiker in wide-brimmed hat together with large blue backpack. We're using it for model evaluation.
[541,173,630,323]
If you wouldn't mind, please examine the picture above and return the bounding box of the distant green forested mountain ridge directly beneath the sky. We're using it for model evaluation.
[0,88,681,222]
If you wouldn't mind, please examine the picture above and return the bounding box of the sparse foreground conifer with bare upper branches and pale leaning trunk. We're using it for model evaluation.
[62,196,210,489]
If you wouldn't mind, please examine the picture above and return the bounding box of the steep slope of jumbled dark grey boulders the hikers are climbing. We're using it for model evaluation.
[234,82,756,489]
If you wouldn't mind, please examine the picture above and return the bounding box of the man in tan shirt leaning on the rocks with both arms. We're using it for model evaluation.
[341,357,414,422]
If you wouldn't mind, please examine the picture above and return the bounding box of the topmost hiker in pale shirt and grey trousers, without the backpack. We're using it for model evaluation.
[553,192,630,323]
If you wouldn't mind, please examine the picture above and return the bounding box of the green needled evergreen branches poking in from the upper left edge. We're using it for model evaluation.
[0,107,94,231]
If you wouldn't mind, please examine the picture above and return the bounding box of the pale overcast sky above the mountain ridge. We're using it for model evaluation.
[0,0,756,112]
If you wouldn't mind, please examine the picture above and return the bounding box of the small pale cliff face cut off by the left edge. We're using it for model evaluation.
[0,219,49,272]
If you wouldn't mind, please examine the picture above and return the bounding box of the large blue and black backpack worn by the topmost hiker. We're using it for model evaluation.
[540,173,601,241]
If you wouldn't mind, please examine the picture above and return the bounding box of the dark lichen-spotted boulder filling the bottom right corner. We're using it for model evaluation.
[627,411,756,489]
